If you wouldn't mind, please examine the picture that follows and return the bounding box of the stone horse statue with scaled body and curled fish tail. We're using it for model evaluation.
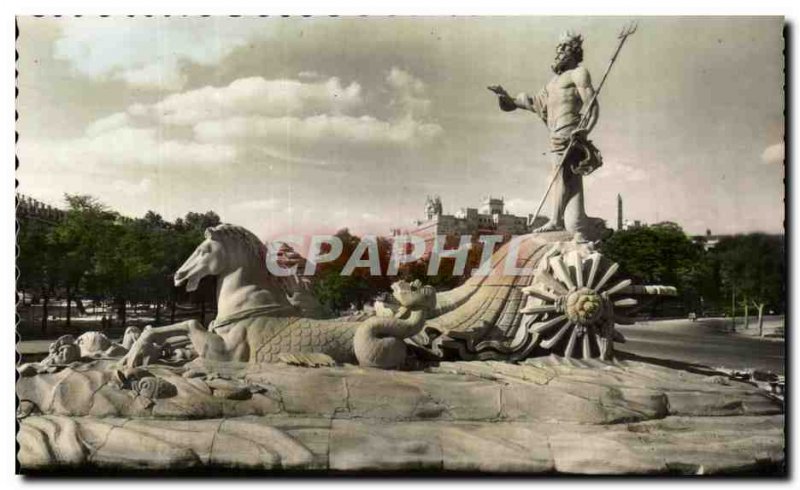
[122,224,435,369]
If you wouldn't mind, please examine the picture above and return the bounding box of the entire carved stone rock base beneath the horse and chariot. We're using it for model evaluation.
[17,358,785,474]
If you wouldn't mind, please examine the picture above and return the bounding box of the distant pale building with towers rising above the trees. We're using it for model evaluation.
[400,196,547,242]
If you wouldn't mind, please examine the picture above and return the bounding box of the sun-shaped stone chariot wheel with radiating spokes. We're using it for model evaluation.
[521,251,644,360]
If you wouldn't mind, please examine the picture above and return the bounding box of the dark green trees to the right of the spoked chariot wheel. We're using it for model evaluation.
[601,222,786,329]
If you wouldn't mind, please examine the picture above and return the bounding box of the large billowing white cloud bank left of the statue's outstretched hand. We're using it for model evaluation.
[76,69,443,165]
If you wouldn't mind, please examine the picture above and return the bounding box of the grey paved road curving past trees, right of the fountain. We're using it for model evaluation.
[616,319,786,374]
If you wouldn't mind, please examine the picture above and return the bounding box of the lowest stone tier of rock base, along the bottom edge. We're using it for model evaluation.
[19,415,784,474]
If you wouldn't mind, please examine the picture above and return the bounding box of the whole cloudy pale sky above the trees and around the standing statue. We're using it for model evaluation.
[17,17,784,238]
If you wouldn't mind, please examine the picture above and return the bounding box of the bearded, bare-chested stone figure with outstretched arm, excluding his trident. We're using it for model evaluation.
[489,32,605,241]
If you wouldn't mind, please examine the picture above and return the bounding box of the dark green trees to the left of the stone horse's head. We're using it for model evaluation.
[16,194,220,331]
